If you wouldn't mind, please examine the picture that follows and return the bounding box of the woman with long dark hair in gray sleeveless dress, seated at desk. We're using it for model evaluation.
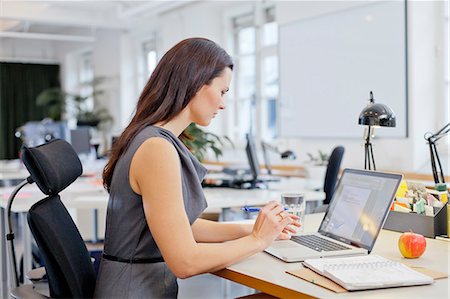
[95,38,299,298]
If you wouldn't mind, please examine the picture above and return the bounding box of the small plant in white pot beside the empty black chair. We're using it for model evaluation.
[305,150,330,190]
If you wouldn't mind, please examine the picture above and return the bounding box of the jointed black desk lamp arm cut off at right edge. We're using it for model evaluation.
[423,123,450,191]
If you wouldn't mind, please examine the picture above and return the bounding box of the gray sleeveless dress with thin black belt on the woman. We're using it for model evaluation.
[94,126,207,298]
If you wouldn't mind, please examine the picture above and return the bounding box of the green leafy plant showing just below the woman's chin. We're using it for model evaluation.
[181,123,234,162]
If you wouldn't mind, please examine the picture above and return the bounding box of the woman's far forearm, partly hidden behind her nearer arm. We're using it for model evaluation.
[191,218,253,243]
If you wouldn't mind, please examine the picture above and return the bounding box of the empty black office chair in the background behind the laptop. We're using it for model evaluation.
[314,146,345,213]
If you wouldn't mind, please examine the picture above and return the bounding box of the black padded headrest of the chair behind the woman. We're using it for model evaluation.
[22,139,83,195]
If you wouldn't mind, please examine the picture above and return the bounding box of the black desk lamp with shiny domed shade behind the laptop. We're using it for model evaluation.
[358,92,395,170]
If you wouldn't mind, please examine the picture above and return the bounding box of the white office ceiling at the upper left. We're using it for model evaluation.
[0,0,198,41]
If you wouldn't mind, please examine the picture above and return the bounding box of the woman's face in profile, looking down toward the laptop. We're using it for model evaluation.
[188,67,231,126]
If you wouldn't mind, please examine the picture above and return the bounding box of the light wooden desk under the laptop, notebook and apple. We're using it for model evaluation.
[214,214,450,298]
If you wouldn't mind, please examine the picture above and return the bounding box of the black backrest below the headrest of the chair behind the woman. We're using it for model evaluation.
[28,195,96,298]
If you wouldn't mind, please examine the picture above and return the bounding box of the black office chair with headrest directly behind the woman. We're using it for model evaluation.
[11,139,96,298]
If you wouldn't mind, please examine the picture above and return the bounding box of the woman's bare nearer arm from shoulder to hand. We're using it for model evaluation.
[130,138,292,278]
